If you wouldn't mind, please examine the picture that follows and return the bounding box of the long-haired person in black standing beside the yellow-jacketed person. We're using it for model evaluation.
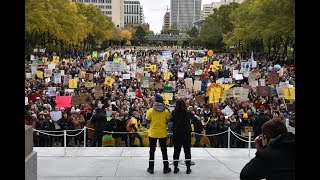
[171,99,194,174]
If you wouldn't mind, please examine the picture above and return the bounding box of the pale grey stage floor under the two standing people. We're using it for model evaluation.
[34,147,256,180]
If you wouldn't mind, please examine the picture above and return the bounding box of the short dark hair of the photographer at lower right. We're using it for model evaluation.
[262,119,288,139]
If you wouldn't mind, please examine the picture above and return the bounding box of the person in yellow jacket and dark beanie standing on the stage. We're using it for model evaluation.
[146,93,171,174]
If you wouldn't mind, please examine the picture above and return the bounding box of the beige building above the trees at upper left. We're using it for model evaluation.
[70,0,124,28]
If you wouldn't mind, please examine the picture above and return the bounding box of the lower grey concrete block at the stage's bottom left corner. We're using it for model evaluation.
[25,151,37,180]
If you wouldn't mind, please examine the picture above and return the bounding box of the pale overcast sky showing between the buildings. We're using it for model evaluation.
[139,0,220,33]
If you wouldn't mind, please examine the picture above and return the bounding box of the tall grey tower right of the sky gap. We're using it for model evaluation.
[170,0,201,31]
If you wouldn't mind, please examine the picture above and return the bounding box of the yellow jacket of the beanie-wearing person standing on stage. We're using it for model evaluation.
[146,108,170,138]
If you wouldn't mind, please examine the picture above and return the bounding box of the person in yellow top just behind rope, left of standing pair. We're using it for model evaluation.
[126,111,144,147]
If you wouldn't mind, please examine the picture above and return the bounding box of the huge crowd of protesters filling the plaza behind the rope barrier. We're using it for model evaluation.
[25,48,295,148]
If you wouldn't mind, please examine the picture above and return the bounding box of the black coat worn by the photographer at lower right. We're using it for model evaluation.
[240,133,296,180]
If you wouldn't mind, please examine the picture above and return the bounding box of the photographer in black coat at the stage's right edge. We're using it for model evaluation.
[240,119,296,180]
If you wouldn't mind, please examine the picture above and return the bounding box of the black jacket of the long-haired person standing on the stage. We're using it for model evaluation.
[171,112,194,143]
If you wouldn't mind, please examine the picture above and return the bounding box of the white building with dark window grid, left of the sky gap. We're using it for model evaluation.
[124,1,141,24]
